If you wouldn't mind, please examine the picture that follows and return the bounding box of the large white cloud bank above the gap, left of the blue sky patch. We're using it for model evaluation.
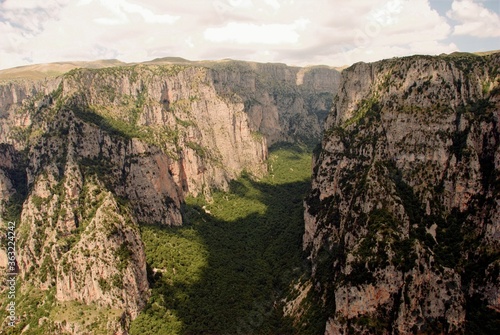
[284,0,457,65]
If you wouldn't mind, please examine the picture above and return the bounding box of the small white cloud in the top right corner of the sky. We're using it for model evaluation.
[446,0,500,37]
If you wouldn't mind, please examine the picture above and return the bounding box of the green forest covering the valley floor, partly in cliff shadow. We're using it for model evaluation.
[130,145,324,335]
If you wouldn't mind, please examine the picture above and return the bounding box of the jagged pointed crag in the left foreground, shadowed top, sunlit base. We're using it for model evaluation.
[11,111,152,331]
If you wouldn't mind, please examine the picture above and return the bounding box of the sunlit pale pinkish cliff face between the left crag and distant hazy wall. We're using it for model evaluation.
[56,65,272,195]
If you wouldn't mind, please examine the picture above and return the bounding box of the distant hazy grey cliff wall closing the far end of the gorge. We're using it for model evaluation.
[210,61,340,145]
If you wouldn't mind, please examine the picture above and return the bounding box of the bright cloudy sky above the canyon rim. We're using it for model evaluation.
[0,0,500,69]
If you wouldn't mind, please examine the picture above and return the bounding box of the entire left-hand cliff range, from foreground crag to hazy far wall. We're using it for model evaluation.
[0,61,339,333]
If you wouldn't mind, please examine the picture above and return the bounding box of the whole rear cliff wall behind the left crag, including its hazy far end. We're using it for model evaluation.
[0,61,339,200]
